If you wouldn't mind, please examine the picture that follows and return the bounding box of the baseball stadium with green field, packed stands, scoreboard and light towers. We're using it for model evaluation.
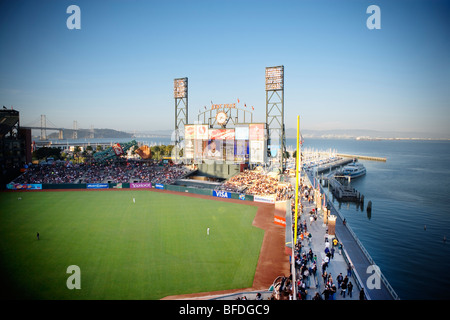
[0,66,294,300]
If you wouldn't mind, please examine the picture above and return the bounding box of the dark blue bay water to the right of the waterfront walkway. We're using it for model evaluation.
[292,139,450,300]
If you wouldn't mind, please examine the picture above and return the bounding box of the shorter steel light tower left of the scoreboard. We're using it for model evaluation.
[173,78,188,143]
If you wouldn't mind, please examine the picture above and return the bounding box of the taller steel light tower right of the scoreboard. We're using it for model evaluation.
[266,66,286,171]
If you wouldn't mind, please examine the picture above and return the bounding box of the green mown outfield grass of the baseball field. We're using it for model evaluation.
[0,190,264,299]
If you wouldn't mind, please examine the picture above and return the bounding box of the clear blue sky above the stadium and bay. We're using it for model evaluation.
[0,0,450,137]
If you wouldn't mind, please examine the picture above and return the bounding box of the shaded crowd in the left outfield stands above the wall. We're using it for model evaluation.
[12,161,190,184]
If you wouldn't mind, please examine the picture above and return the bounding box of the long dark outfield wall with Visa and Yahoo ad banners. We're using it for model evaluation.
[6,182,254,201]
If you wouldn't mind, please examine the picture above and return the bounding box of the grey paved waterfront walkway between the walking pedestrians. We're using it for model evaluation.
[298,182,359,300]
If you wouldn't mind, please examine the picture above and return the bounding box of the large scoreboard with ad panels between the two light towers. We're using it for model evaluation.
[183,123,267,164]
